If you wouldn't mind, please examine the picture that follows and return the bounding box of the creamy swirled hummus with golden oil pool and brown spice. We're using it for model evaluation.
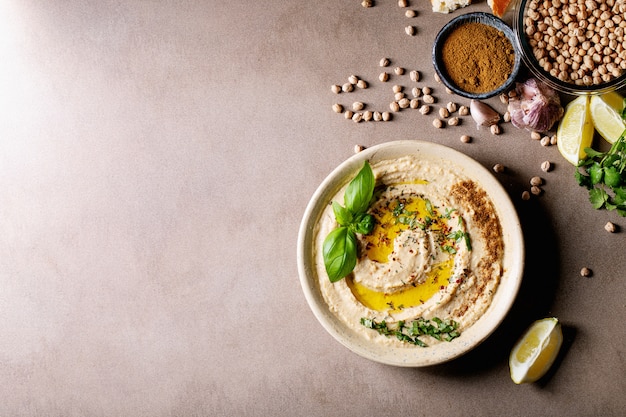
[315,156,503,345]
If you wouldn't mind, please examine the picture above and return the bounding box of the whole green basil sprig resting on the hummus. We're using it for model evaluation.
[322,161,376,282]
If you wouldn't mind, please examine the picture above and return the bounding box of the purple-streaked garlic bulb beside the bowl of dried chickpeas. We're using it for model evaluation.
[509,78,564,132]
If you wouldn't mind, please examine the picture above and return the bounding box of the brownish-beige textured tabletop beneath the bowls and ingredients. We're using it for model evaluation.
[0,0,626,416]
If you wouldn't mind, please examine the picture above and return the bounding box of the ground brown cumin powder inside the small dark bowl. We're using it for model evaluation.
[441,23,515,93]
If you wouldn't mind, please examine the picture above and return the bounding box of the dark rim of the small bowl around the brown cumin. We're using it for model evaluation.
[432,12,521,100]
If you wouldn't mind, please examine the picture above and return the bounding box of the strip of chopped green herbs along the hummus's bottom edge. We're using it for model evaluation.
[361,317,461,347]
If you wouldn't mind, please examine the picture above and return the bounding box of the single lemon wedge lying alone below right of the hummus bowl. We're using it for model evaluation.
[509,317,563,384]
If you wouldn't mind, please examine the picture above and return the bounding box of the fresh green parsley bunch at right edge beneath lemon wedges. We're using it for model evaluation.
[575,99,626,217]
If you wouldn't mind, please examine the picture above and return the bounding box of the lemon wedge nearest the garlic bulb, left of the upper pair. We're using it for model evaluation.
[556,96,594,165]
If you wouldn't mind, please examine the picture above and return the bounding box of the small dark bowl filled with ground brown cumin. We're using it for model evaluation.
[432,12,521,100]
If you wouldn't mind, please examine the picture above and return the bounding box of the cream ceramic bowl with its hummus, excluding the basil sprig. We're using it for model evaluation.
[297,140,524,367]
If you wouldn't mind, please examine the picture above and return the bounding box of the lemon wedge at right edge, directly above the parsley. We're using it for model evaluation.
[590,92,626,143]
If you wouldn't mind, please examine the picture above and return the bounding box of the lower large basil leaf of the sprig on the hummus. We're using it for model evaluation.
[322,226,357,282]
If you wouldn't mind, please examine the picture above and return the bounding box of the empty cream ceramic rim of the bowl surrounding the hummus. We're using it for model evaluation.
[297,141,524,367]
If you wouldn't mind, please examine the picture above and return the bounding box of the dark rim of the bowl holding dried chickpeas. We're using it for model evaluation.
[513,0,626,95]
